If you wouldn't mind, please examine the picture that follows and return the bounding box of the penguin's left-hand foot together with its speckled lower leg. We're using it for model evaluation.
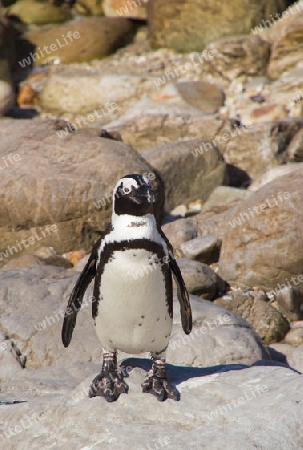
[88,353,128,402]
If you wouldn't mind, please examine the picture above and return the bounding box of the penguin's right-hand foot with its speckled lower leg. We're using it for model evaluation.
[141,359,180,402]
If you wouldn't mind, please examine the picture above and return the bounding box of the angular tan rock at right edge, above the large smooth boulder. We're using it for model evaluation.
[217,119,303,178]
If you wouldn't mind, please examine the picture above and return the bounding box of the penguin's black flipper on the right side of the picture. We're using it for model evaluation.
[160,230,192,334]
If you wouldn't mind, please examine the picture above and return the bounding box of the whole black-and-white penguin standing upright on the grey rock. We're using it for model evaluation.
[62,174,192,401]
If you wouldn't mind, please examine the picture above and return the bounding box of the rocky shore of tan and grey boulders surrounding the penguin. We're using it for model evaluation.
[0,0,303,450]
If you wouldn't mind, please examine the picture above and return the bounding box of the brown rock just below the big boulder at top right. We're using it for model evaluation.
[203,33,270,82]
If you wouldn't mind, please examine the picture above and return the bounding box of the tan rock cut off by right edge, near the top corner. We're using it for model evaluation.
[267,11,303,79]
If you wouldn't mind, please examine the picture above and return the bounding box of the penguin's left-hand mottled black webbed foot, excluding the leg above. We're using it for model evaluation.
[88,372,129,402]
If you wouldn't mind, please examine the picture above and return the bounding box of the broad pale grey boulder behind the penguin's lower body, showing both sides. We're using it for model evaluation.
[0,266,269,368]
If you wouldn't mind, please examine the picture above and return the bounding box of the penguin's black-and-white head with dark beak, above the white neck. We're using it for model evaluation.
[113,174,155,216]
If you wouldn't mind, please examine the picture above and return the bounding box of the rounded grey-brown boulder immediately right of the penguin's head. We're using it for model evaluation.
[141,140,226,210]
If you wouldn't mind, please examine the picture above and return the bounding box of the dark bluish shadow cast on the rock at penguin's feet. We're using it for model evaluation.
[120,358,301,395]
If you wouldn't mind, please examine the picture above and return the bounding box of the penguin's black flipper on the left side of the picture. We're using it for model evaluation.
[61,236,103,347]
